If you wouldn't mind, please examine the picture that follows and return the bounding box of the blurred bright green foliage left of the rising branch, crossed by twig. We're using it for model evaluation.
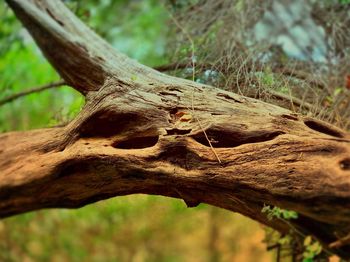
[0,3,84,132]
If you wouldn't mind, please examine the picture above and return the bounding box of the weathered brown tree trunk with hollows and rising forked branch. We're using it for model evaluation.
[0,0,350,257]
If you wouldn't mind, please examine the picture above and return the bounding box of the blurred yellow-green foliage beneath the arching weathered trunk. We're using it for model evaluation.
[0,195,270,262]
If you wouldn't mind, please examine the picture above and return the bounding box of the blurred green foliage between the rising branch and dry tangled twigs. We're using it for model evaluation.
[67,0,169,66]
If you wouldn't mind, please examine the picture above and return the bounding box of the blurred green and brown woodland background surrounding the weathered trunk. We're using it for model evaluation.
[0,0,350,262]
